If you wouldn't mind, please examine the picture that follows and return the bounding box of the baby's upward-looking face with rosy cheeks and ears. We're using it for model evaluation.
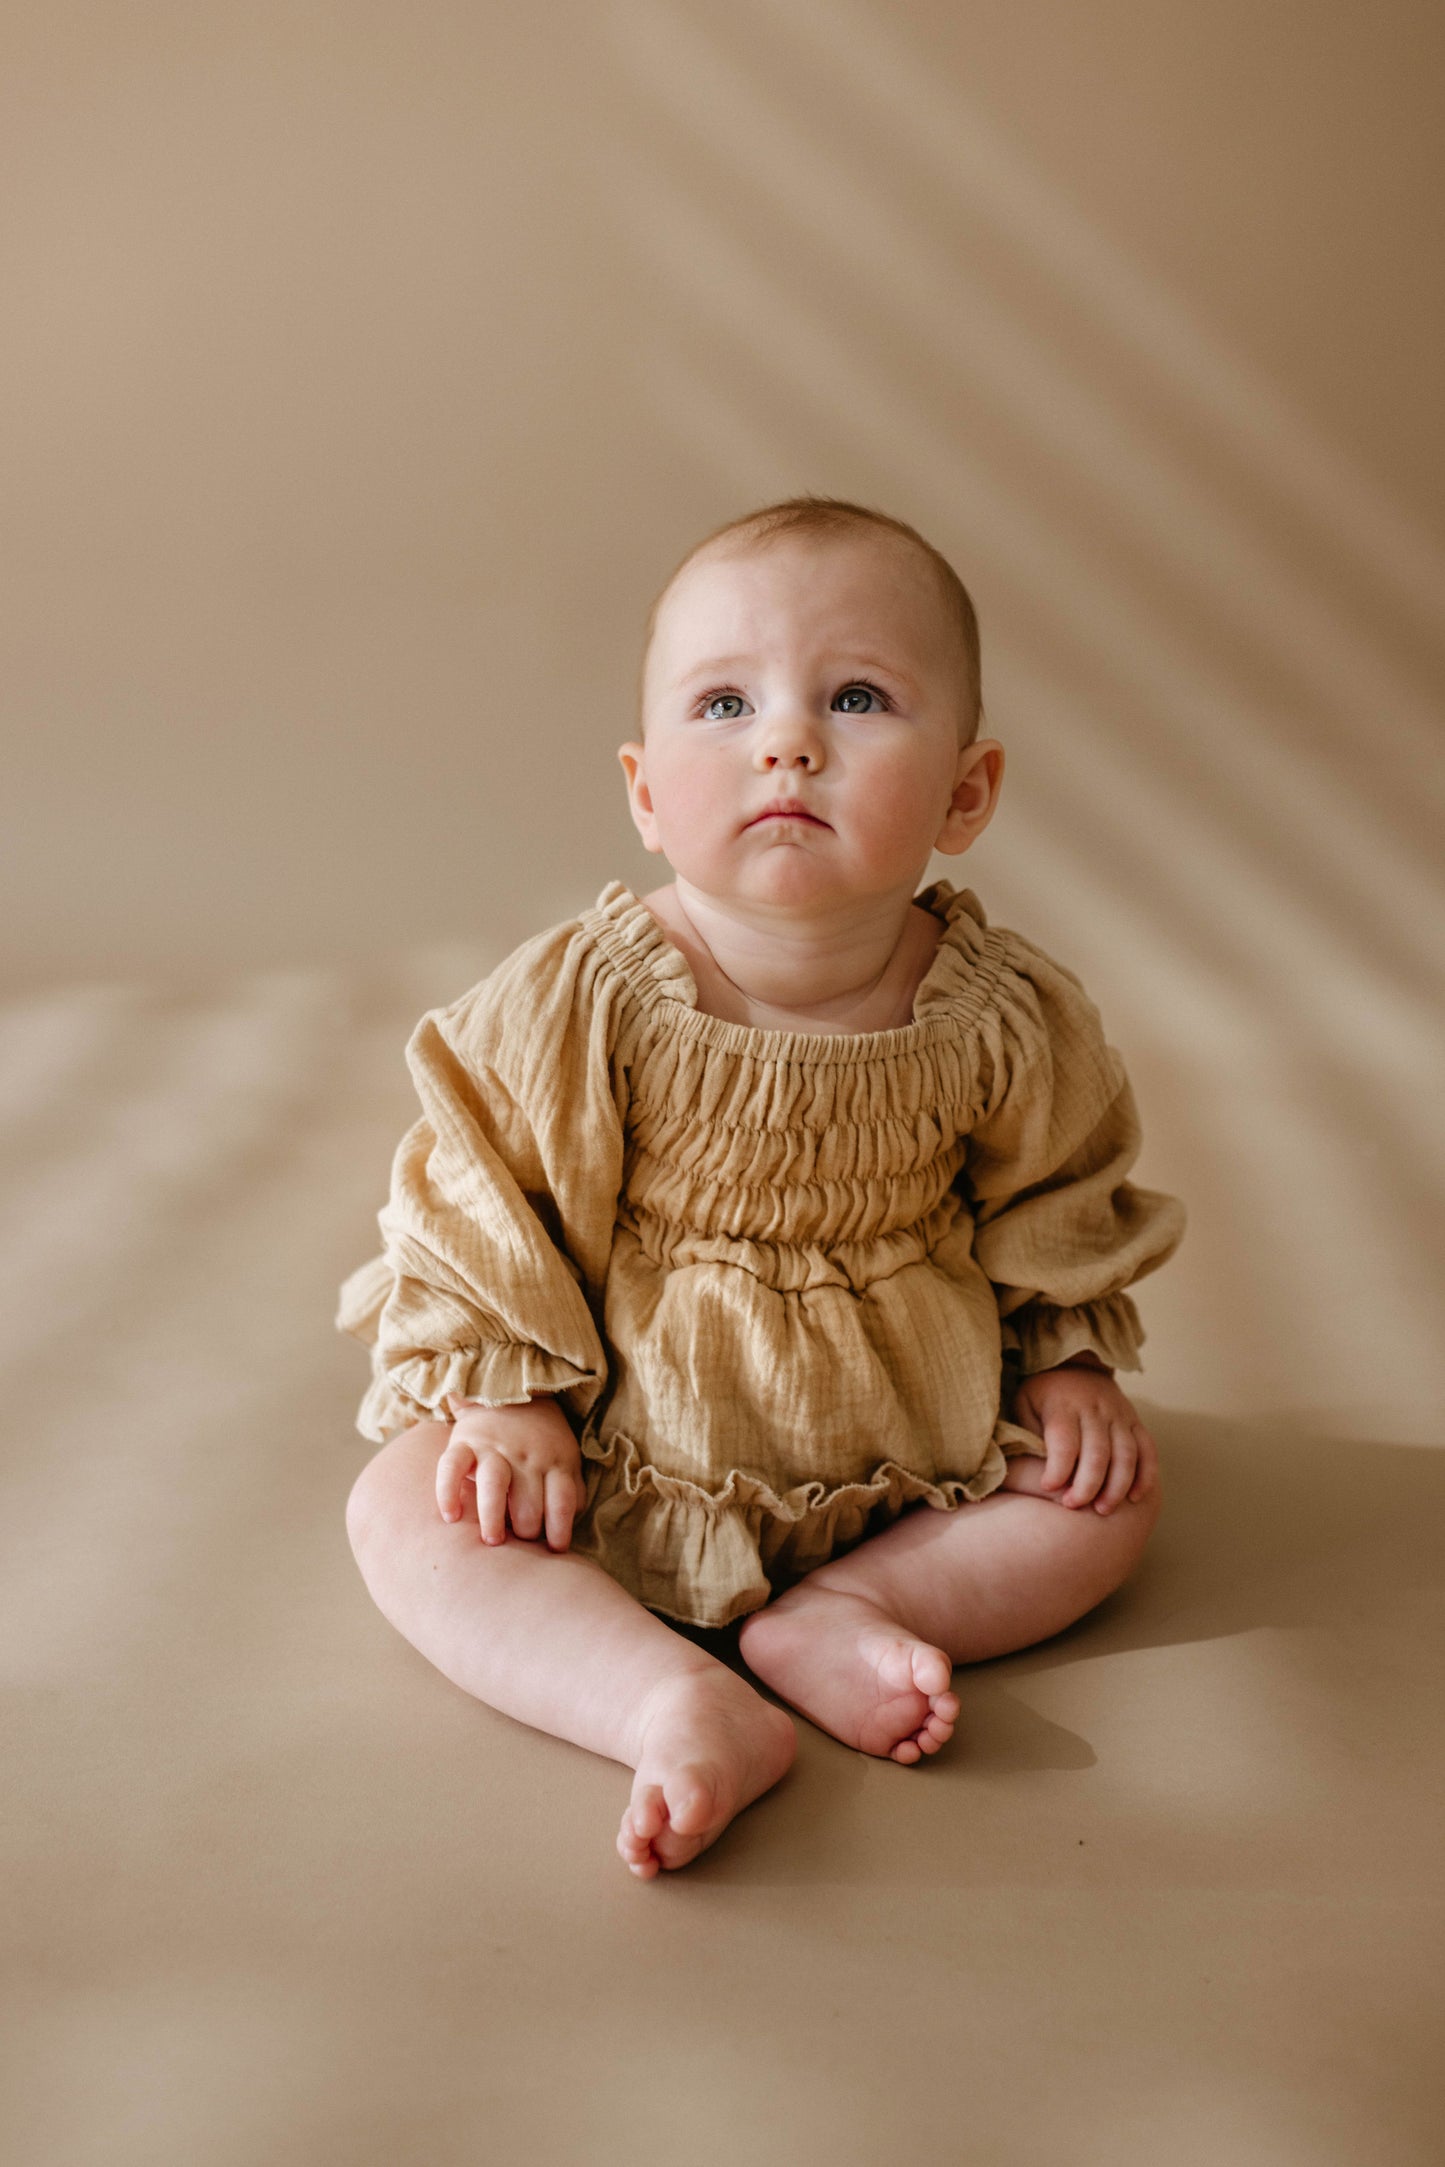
[620,533,1001,912]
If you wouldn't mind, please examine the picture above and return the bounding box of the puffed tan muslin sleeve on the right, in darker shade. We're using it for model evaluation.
[960,934,1185,1376]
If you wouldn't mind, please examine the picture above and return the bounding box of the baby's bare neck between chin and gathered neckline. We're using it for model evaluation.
[641,882,942,1034]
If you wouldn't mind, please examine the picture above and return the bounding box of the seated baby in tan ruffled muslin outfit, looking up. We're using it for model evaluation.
[338,498,1183,1879]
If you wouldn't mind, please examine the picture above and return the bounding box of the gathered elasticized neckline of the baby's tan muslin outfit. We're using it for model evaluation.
[581,880,1005,1066]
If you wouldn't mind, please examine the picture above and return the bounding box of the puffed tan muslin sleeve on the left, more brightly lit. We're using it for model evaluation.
[336,923,626,1443]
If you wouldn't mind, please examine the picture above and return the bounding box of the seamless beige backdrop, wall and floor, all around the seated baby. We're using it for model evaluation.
[0,0,1445,2167]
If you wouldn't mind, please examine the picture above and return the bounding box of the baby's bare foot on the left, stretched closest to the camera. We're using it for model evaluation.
[617,1664,797,1881]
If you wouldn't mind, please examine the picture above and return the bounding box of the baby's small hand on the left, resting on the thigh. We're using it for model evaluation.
[435,1398,585,1549]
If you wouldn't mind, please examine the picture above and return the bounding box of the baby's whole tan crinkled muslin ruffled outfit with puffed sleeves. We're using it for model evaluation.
[338,880,1183,1625]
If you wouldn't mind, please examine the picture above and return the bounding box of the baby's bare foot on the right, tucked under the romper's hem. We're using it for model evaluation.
[739,1582,958,1766]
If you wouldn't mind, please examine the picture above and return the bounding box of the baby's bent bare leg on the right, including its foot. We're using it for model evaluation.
[739,1458,1159,1762]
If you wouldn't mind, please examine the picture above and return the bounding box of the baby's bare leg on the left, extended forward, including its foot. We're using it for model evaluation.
[347,1422,797,1879]
